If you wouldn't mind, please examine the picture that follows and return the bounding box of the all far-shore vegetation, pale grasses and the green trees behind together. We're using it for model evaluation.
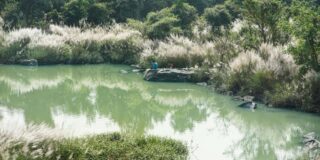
[0,0,320,113]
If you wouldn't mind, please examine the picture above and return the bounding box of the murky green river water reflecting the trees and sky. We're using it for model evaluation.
[0,65,320,160]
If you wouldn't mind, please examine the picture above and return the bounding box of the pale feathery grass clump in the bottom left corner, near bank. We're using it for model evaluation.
[0,124,66,159]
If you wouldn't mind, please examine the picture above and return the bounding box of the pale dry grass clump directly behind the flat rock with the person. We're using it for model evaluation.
[142,35,234,68]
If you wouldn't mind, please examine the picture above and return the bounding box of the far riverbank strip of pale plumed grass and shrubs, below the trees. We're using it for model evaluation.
[0,24,320,113]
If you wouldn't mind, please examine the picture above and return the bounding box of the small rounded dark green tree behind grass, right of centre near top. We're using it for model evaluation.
[203,5,231,31]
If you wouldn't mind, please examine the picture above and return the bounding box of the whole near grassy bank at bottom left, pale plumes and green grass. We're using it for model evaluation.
[0,127,188,160]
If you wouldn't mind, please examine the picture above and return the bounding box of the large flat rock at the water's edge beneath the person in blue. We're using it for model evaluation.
[144,69,194,82]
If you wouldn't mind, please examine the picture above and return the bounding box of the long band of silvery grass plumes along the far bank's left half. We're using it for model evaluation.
[5,24,141,48]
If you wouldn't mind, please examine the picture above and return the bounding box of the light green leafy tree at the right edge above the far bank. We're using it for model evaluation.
[286,1,320,72]
